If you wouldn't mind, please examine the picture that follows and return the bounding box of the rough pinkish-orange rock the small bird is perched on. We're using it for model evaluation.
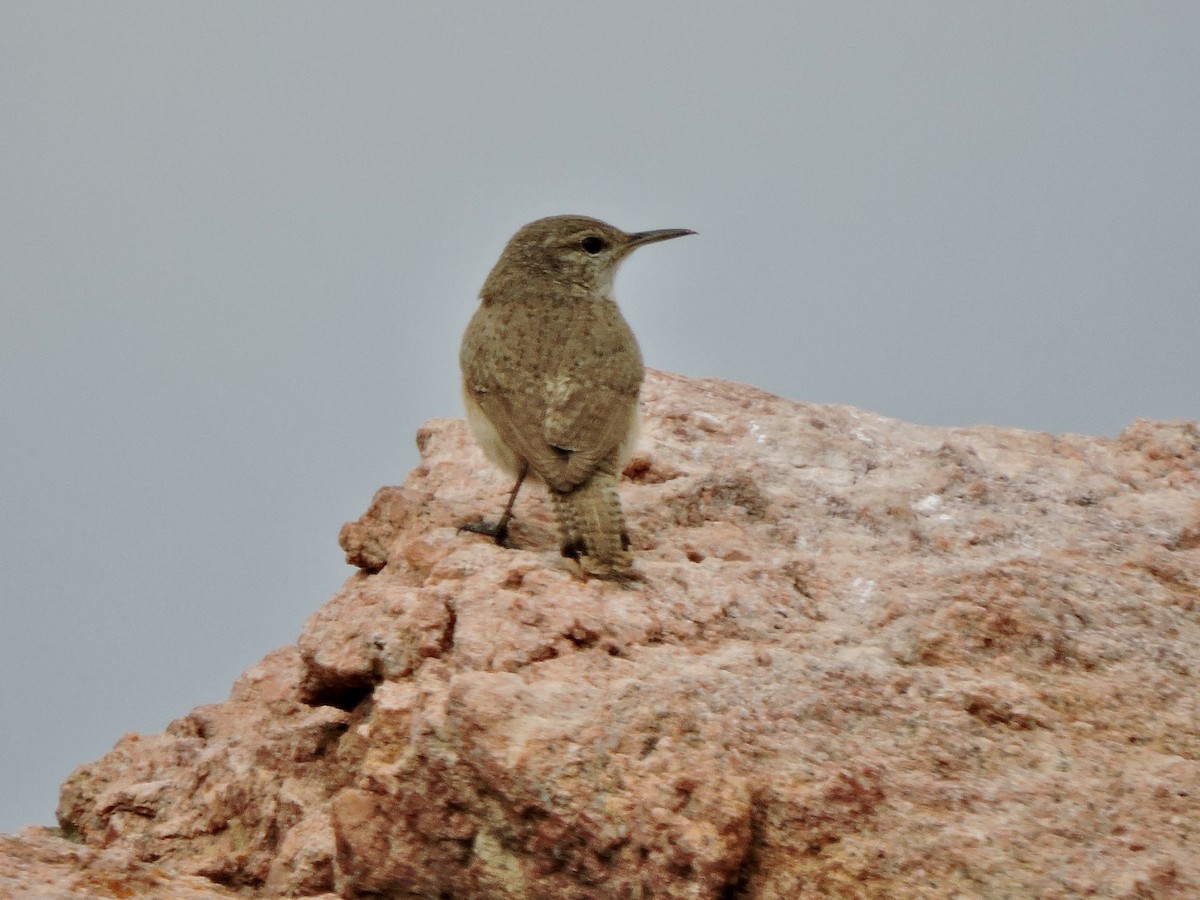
[9,372,1200,900]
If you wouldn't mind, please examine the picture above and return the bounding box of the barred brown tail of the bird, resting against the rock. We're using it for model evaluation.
[551,470,636,581]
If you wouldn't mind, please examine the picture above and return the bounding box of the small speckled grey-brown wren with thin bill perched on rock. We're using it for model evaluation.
[458,216,695,580]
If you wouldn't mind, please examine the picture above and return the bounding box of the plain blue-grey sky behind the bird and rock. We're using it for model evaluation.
[0,0,1200,832]
